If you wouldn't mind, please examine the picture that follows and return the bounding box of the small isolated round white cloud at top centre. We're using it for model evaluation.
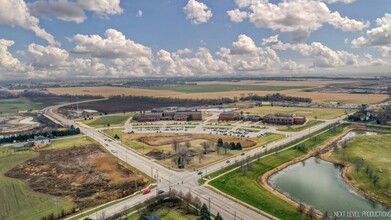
[183,0,213,24]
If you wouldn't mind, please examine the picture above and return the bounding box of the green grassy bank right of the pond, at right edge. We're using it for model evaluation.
[331,134,391,207]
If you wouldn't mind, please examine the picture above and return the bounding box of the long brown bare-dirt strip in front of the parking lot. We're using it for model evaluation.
[133,134,256,148]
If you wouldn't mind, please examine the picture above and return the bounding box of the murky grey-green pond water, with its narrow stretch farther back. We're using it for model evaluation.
[269,132,391,219]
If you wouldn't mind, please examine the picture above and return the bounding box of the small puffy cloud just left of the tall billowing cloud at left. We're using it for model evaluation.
[27,43,69,68]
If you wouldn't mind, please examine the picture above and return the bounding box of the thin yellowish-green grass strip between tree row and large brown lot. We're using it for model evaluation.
[41,136,96,150]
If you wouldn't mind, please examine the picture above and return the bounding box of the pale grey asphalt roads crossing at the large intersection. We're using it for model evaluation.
[43,103,340,220]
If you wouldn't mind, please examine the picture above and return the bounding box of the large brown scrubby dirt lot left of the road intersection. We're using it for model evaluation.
[5,144,148,208]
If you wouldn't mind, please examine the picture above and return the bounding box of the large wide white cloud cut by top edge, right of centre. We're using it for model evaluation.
[231,0,369,41]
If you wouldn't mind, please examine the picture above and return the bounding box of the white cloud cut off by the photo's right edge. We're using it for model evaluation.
[351,14,391,56]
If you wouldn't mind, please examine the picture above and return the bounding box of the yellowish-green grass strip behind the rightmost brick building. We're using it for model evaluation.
[241,106,345,119]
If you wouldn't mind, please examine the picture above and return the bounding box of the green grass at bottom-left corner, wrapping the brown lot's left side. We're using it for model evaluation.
[0,152,73,220]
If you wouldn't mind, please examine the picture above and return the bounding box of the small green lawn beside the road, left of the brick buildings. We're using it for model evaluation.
[80,113,133,128]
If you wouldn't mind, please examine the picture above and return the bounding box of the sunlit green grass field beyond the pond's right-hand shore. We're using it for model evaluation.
[332,135,391,204]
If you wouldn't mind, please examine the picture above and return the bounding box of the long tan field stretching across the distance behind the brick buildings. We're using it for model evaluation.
[48,84,388,104]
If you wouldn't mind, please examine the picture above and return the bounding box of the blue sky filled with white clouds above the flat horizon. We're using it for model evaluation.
[0,0,391,80]
